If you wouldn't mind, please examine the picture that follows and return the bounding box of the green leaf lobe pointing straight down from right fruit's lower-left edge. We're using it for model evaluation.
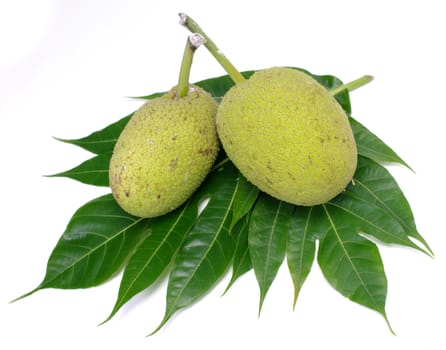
[248,193,295,315]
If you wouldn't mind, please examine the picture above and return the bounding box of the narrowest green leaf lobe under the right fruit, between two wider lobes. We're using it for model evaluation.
[287,207,316,306]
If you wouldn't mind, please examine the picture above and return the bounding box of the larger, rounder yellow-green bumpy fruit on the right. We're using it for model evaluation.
[216,67,357,206]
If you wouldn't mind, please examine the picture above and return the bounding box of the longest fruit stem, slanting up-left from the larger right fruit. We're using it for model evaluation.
[179,13,245,84]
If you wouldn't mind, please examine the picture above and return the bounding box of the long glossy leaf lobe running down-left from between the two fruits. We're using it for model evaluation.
[151,162,242,334]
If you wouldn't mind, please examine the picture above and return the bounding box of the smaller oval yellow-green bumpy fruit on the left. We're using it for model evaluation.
[109,86,219,218]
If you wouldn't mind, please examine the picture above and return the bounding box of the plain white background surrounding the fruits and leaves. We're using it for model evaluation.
[0,0,446,350]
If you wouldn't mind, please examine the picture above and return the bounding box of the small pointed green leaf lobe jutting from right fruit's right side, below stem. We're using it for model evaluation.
[349,117,412,170]
